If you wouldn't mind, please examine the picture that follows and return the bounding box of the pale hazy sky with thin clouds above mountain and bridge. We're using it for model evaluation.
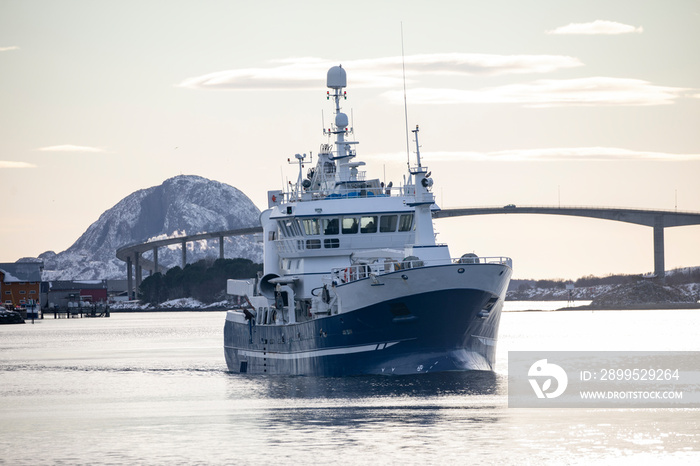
[0,0,700,279]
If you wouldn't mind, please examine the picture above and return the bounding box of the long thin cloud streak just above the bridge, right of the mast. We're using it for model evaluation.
[368,147,700,164]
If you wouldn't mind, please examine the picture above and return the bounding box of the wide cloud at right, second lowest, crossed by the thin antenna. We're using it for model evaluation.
[383,77,690,107]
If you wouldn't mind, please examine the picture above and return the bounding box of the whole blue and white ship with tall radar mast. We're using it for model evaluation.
[224,66,512,376]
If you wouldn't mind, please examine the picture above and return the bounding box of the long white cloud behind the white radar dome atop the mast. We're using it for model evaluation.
[178,53,583,90]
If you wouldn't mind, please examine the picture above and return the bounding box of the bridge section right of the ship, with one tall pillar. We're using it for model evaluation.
[433,204,700,277]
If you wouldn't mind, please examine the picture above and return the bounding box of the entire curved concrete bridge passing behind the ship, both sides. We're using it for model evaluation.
[117,204,700,297]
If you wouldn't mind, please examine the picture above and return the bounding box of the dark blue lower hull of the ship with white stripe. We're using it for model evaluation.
[224,289,502,376]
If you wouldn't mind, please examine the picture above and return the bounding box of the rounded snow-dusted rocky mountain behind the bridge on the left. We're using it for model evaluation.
[34,175,262,280]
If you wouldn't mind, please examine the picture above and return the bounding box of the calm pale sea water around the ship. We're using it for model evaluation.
[0,303,700,465]
